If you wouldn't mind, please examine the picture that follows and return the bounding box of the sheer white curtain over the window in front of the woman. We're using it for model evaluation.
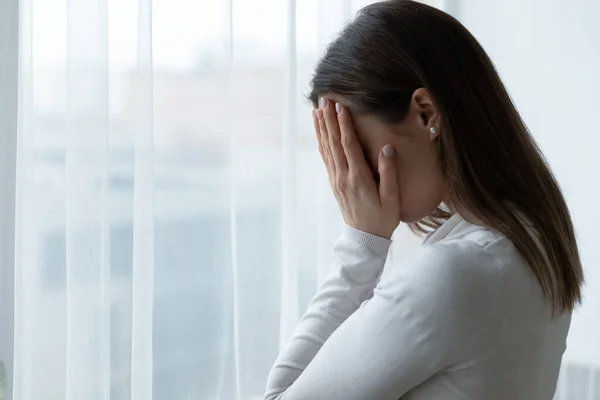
[0,0,600,400]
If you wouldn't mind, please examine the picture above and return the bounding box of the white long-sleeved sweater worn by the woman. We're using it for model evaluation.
[265,215,571,400]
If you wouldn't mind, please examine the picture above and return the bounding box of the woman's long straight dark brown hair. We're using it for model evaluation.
[309,0,583,313]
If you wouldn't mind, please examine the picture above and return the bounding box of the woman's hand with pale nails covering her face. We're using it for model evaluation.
[313,98,400,239]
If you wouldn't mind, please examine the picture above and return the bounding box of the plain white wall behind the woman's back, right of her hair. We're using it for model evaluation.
[446,0,600,365]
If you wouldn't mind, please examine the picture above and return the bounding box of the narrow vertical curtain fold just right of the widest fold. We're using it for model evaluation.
[131,0,155,400]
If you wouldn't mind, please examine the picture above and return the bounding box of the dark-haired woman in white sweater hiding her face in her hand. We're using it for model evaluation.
[266,0,583,400]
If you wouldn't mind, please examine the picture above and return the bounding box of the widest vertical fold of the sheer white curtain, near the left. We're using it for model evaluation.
[64,0,110,400]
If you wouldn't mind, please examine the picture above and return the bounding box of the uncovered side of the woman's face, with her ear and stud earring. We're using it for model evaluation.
[327,89,446,223]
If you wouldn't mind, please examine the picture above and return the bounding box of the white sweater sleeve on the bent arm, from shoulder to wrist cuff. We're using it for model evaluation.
[265,238,503,400]
